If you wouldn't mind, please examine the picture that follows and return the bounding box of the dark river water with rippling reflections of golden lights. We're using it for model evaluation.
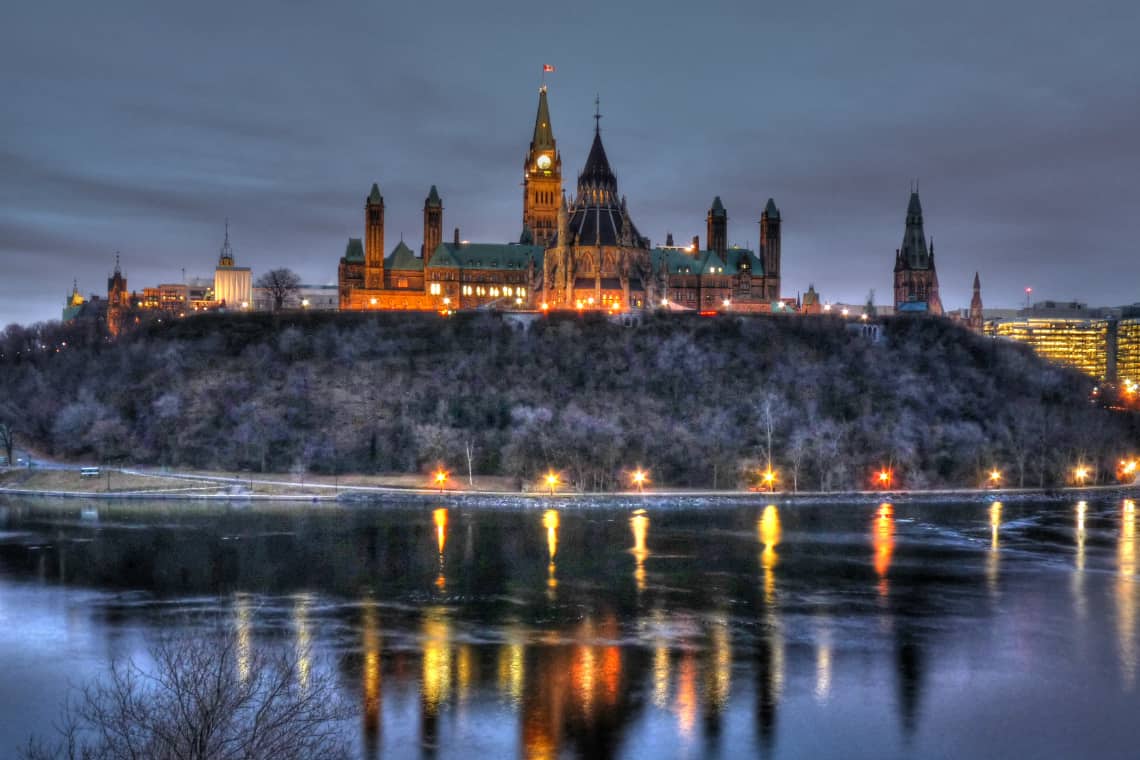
[0,500,1140,760]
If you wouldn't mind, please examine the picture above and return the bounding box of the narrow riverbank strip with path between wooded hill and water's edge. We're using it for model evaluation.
[0,468,1140,507]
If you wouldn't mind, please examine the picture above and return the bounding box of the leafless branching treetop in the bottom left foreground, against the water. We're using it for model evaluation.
[22,635,350,760]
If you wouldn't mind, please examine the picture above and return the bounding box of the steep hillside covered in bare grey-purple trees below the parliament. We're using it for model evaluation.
[0,313,1137,490]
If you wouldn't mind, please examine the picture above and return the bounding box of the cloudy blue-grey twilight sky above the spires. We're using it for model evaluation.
[0,0,1140,325]
